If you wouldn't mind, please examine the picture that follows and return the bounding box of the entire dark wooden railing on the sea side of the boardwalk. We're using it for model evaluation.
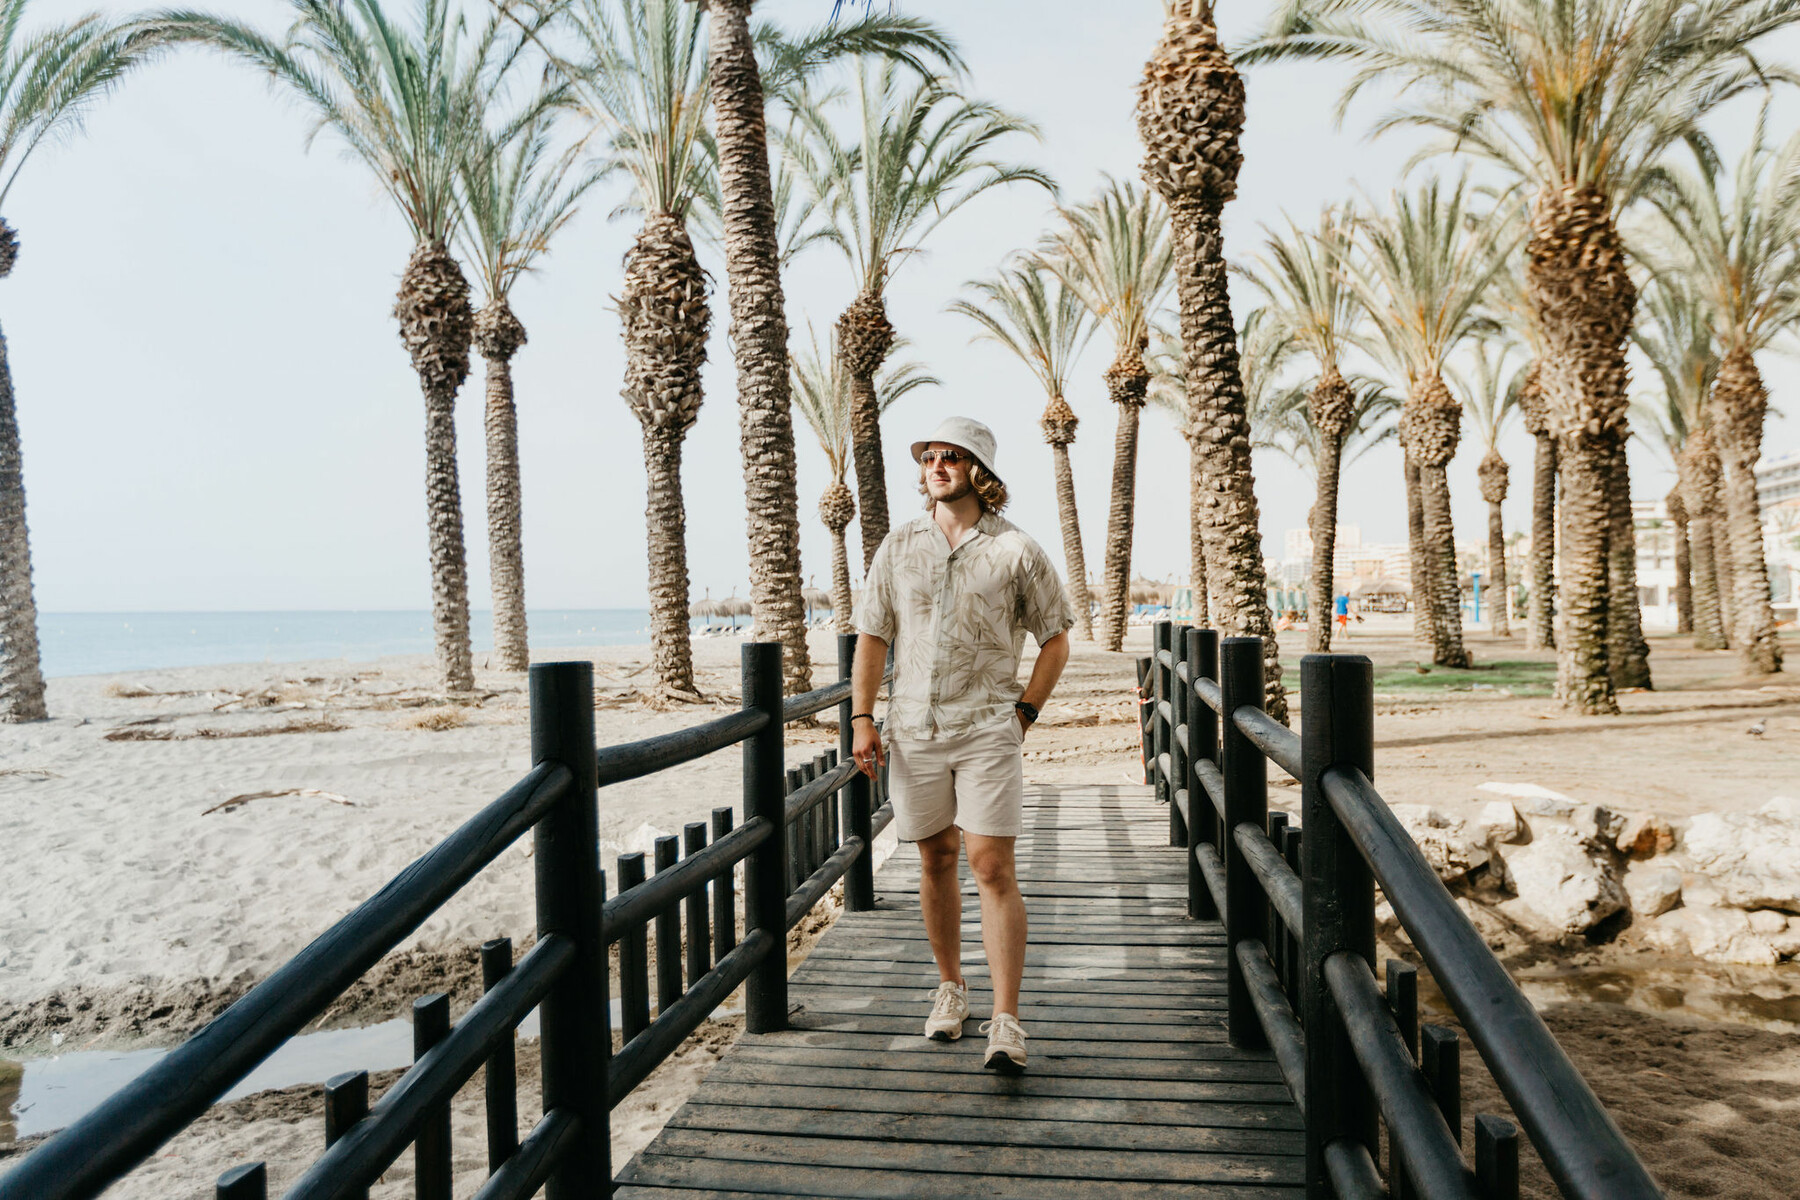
[0,635,893,1200]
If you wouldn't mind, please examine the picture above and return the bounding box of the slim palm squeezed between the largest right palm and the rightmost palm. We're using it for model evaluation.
[1633,273,1730,649]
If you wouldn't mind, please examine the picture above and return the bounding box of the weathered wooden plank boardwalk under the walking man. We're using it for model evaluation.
[616,786,1303,1200]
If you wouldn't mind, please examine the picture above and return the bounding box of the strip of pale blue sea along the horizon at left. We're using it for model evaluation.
[38,608,723,678]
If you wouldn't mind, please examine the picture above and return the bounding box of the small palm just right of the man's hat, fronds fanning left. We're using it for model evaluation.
[950,261,1094,640]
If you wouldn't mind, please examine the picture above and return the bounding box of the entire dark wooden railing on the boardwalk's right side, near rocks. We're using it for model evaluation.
[1138,622,1661,1200]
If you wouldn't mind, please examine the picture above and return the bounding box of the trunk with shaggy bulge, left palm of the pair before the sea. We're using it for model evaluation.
[394,241,475,691]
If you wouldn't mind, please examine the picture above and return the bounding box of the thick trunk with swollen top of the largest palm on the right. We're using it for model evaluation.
[1525,185,1638,714]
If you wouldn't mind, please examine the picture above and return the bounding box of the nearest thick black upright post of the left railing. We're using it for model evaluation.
[531,662,612,1200]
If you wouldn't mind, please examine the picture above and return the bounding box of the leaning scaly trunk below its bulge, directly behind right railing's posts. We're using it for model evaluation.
[1172,200,1287,721]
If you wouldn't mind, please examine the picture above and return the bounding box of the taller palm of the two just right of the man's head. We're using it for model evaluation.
[1039,178,1175,649]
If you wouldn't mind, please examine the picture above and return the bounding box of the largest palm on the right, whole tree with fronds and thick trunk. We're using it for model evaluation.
[1244,0,1800,712]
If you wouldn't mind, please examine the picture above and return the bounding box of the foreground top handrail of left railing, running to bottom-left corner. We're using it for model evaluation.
[0,763,574,1200]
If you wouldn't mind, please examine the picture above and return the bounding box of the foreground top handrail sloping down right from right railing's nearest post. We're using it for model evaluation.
[1319,766,1661,1198]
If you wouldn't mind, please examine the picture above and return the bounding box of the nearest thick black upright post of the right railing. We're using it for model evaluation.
[1300,655,1379,1200]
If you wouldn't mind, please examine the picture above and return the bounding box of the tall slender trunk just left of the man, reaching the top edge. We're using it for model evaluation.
[707,0,812,694]
